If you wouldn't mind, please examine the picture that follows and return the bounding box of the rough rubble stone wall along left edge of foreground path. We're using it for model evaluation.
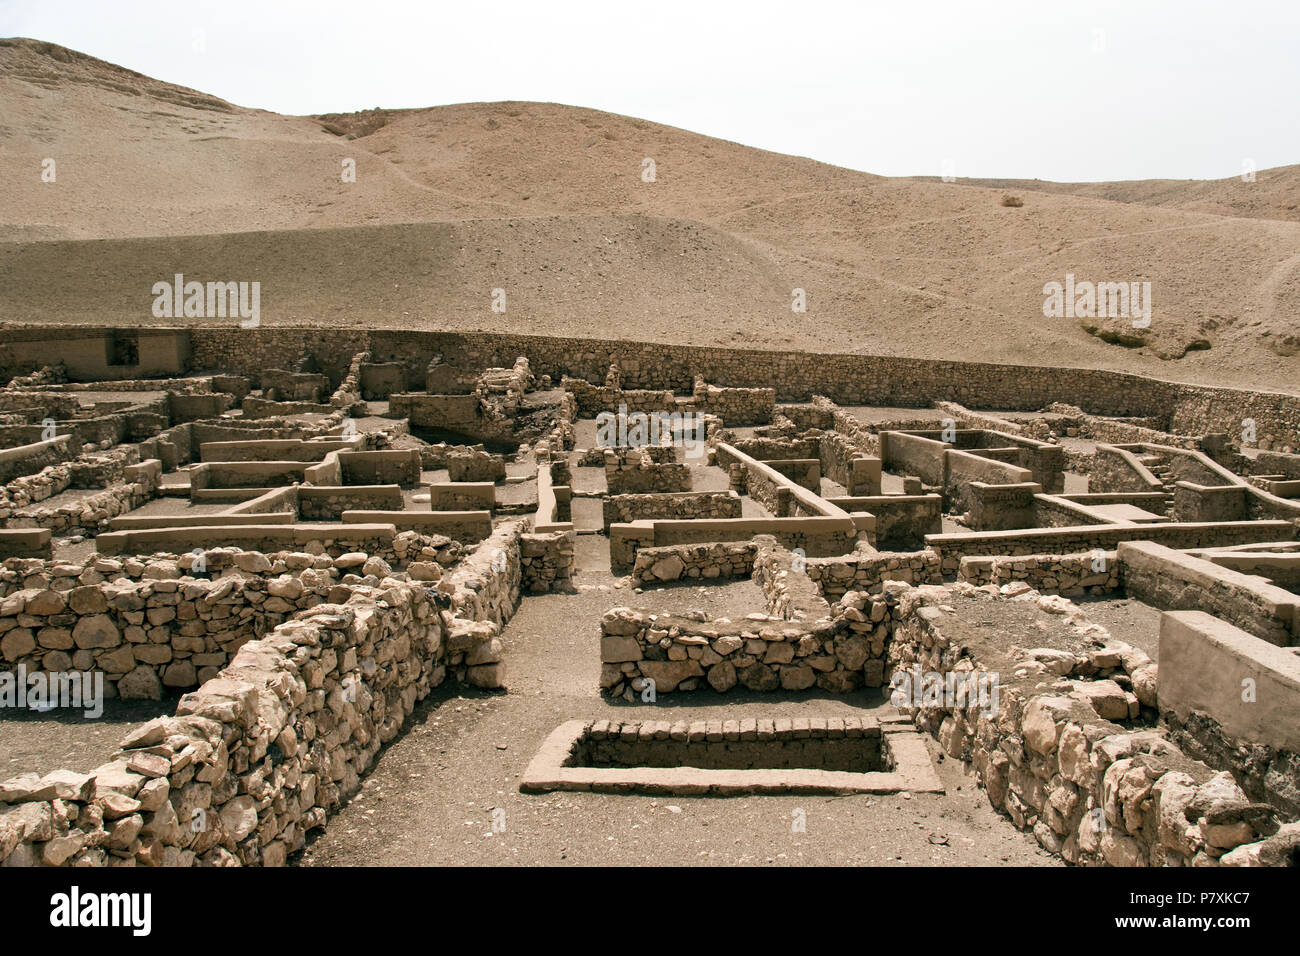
[0,583,451,866]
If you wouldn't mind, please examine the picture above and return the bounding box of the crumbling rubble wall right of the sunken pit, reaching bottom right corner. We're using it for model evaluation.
[888,585,1300,866]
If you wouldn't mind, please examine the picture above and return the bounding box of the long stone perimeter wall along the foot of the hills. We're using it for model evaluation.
[22,326,1300,450]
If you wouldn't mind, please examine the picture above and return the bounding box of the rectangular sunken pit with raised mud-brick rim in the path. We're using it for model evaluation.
[520,717,944,796]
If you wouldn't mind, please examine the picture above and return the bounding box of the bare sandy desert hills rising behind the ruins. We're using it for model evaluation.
[0,39,1300,390]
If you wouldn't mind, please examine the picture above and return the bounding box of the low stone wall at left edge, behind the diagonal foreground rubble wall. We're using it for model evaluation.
[0,529,460,698]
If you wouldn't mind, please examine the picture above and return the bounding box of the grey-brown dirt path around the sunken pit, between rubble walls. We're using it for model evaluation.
[298,535,1060,866]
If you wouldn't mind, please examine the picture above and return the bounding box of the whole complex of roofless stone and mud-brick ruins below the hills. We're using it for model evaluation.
[0,329,1300,865]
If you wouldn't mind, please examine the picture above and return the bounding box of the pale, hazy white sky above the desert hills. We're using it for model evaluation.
[0,0,1300,181]
